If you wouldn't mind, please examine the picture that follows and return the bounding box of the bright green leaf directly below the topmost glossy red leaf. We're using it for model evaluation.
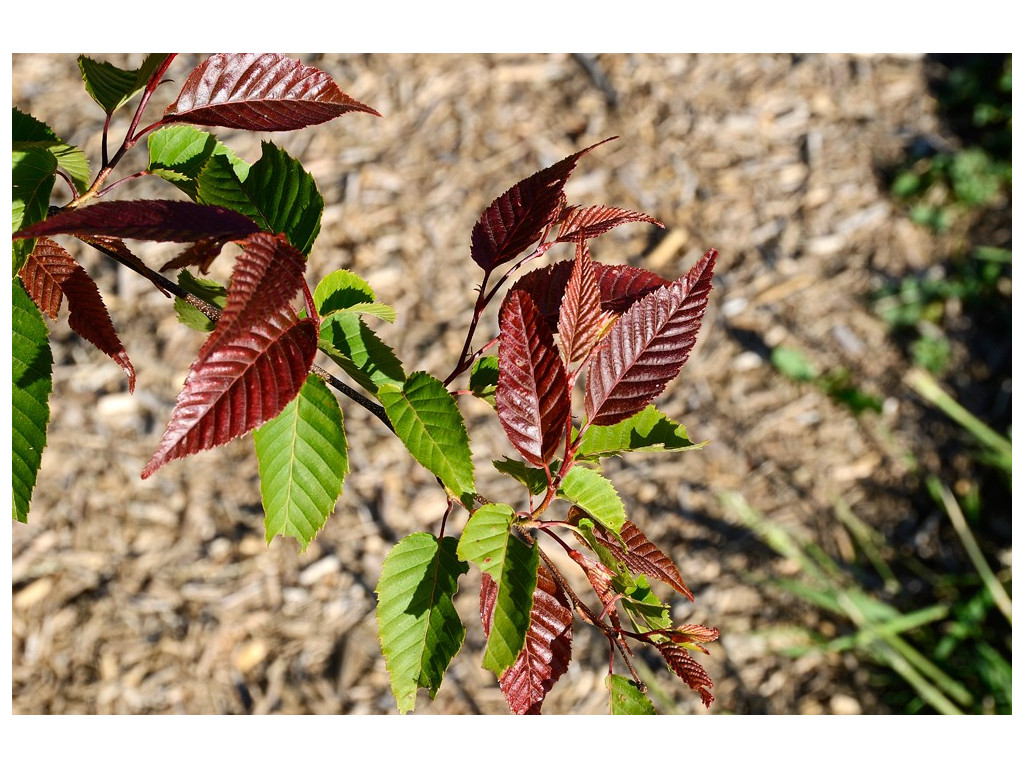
[147,125,249,202]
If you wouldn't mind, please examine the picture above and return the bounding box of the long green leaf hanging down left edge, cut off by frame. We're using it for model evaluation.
[11,280,53,522]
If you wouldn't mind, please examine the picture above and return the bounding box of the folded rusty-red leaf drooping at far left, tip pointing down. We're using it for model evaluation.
[19,238,135,392]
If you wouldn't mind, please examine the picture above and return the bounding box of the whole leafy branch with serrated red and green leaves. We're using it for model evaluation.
[12,53,718,714]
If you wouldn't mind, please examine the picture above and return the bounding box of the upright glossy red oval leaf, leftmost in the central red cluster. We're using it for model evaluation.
[495,291,570,467]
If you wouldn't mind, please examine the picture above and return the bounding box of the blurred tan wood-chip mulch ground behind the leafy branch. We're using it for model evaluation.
[12,54,1010,714]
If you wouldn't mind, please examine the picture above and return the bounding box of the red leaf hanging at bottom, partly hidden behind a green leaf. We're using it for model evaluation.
[480,564,572,715]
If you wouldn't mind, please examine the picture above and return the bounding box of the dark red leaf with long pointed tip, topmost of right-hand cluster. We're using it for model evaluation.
[470,137,614,274]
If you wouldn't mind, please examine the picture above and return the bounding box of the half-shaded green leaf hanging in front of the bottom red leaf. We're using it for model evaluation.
[458,504,540,677]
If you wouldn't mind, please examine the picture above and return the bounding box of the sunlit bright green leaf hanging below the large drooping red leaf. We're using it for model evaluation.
[253,375,348,552]
